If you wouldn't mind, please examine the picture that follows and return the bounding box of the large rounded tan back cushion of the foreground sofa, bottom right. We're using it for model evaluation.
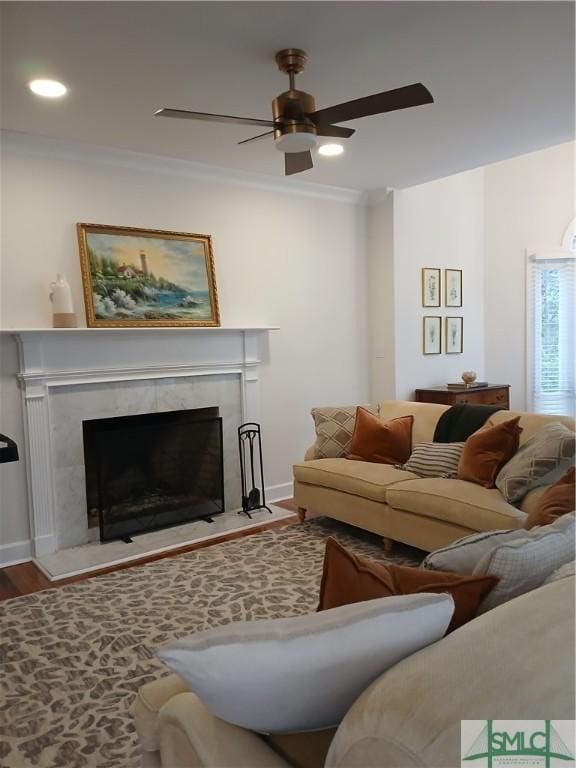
[325,579,574,768]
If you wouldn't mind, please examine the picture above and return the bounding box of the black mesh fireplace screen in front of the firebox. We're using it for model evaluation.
[83,408,224,541]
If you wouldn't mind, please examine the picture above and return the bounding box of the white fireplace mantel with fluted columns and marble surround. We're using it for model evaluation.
[10,326,276,557]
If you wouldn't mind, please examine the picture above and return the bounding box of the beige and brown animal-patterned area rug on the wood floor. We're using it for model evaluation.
[0,518,422,768]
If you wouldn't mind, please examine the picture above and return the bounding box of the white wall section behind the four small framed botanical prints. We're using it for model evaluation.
[394,169,486,400]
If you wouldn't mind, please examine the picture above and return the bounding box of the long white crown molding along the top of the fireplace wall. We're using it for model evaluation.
[0,129,363,204]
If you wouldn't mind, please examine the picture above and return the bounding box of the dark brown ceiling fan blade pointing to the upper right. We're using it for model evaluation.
[310,83,434,125]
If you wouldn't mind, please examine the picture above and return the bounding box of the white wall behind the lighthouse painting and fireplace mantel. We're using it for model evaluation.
[0,130,367,544]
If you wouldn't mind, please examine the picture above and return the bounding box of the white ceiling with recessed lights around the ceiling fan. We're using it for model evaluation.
[1,1,574,189]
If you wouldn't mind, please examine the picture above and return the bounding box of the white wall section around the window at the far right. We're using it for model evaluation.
[484,143,575,410]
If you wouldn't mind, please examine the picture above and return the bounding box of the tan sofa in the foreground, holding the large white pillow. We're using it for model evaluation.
[135,577,575,768]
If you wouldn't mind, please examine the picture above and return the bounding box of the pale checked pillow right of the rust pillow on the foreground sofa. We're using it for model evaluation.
[473,515,575,614]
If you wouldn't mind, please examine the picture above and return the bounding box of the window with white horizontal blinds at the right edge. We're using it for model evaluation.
[528,256,576,416]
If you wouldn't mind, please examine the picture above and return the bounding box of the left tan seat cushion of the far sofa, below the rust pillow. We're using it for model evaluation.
[294,459,416,502]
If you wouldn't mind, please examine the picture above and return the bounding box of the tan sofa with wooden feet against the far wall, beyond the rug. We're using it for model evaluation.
[294,400,574,552]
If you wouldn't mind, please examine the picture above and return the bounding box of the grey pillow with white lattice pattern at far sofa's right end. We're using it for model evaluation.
[496,422,576,504]
